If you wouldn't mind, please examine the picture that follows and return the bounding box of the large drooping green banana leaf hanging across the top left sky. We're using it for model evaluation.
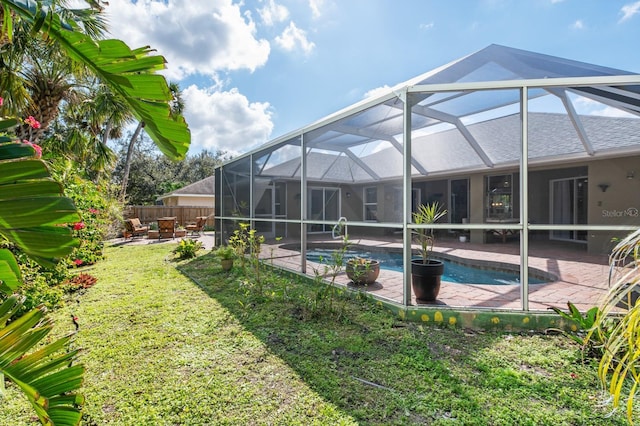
[0,0,191,160]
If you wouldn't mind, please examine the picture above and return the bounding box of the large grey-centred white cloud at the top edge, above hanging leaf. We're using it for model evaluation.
[106,0,270,80]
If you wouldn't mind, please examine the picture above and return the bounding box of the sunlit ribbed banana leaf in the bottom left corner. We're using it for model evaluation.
[0,295,84,426]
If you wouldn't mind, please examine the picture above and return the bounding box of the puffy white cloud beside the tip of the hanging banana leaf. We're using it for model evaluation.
[183,85,273,155]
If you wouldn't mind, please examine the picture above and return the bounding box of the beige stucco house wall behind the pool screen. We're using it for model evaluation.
[276,156,640,253]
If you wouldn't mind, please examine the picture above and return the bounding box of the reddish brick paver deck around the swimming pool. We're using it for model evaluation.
[261,238,609,311]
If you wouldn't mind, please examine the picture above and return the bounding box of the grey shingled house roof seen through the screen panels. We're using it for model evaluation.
[261,113,640,183]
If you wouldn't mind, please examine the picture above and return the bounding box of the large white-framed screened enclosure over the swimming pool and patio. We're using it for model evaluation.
[216,45,640,311]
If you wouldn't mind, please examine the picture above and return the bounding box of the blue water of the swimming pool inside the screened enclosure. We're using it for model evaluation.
[307,249,547,285]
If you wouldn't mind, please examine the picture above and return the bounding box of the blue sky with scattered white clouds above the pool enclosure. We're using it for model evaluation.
[99,0,640,156]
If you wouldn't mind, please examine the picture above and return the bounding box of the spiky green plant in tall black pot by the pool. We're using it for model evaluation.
[411,201,447,302]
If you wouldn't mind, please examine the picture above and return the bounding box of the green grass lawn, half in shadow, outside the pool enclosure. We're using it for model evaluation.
[0,244,625,425]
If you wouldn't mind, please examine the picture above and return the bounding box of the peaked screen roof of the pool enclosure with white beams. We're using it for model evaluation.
[223,45,640,182]
